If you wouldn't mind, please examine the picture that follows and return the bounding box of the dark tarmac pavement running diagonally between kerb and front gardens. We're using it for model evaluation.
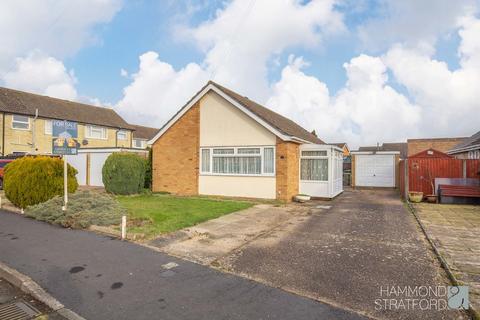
[0,211,360,320]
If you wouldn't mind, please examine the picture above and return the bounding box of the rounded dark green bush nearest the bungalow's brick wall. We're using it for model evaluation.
[102,152,145,194]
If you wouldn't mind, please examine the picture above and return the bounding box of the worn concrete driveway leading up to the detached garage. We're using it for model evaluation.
[157,190,466,319]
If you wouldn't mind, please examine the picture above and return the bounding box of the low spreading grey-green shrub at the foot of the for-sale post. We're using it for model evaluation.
[25,191,126,228]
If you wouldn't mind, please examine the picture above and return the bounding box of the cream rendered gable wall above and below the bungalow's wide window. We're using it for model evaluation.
[198,92,276,199]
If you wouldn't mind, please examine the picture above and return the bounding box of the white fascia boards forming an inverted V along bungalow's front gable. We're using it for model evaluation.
[148,84,290,144]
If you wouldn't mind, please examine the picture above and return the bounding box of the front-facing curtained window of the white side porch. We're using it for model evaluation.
[300,150,328,181]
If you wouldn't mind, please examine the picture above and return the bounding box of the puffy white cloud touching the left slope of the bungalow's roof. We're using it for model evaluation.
[116,51,208,127]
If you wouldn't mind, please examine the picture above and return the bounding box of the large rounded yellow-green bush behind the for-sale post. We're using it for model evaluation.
[3,157,78,208]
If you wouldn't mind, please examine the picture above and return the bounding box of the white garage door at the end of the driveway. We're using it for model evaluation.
[355,154,395,187]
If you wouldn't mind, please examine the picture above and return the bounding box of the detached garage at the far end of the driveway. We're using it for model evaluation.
[352,151,400,188]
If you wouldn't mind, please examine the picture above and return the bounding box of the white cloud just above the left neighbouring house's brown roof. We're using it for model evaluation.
[2,51,77,100]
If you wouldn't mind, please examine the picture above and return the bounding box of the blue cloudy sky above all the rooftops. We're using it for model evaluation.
[0,0,480,147]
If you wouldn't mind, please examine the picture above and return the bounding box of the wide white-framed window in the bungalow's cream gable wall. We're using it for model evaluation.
[200,146,275,176]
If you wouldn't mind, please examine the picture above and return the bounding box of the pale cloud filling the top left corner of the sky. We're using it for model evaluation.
[0,0,122,71]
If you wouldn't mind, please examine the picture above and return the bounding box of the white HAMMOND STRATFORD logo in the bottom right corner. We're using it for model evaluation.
[375,286,469,311]
